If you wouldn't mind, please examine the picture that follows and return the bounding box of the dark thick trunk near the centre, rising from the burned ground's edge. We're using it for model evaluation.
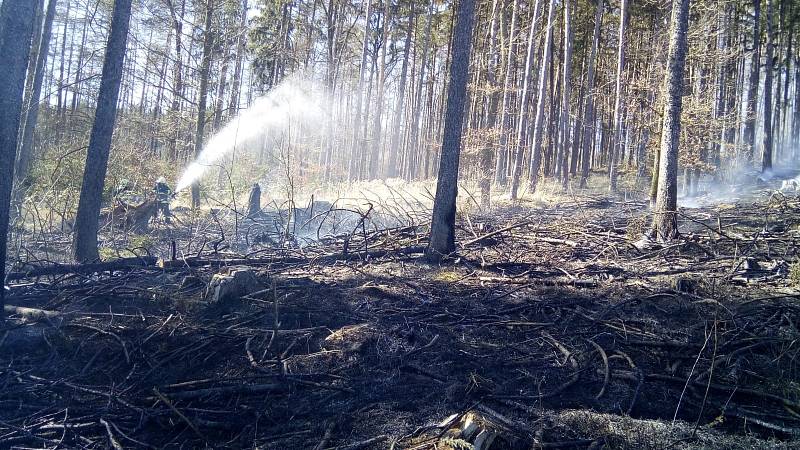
[425,0,475,261]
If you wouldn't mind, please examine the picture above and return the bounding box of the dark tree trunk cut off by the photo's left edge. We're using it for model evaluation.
[0,0,35,324]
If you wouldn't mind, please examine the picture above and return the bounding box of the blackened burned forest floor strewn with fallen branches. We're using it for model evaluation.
[0,173,800,450]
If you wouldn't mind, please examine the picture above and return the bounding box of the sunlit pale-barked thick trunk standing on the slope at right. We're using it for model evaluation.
[652,0,689,241]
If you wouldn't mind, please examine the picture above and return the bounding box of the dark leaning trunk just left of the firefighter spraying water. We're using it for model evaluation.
[72,0,131,262]
